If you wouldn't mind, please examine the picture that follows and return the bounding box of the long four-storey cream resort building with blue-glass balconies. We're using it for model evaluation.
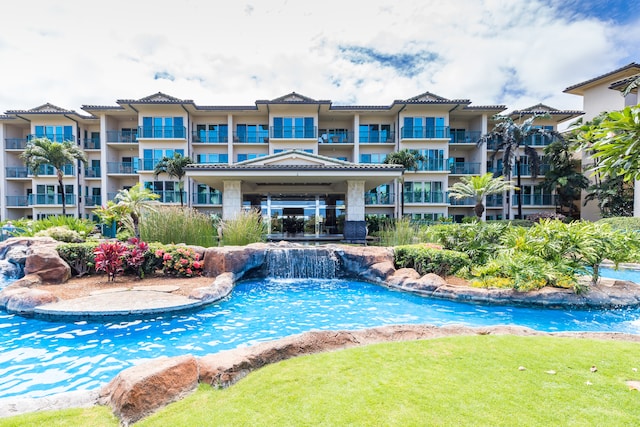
[0,92,582,237]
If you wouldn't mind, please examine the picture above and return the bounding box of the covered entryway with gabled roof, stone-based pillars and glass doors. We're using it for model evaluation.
[186,150,403,240]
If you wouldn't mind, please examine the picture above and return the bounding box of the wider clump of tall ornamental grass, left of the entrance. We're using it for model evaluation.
[140,206,218,248]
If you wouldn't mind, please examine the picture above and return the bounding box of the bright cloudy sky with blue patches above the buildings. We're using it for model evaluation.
[0,0,640,113]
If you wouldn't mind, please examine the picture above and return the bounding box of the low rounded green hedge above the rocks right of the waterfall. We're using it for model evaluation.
[395,245,470,277]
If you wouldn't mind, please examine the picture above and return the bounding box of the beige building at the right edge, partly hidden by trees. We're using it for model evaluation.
[564,62,640,221]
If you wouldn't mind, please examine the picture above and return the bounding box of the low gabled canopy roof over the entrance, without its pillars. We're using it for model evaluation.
[186,150,403,197]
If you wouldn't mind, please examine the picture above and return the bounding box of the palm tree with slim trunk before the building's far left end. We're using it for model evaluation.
[20,138,87,215]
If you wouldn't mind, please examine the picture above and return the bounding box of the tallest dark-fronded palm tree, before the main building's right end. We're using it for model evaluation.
[478,113,563,218]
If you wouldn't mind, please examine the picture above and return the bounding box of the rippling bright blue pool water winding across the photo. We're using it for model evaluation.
[0,279,640,397]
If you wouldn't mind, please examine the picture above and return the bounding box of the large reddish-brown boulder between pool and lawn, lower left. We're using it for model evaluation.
[99,355,198,425]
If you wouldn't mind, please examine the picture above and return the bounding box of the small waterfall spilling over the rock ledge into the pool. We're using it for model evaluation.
[266,248,338,279]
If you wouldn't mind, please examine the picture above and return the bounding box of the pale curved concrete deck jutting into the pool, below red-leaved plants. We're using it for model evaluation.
[33,286,207,321]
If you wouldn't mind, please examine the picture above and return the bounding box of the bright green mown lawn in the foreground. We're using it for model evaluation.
[5,335,640,427]
